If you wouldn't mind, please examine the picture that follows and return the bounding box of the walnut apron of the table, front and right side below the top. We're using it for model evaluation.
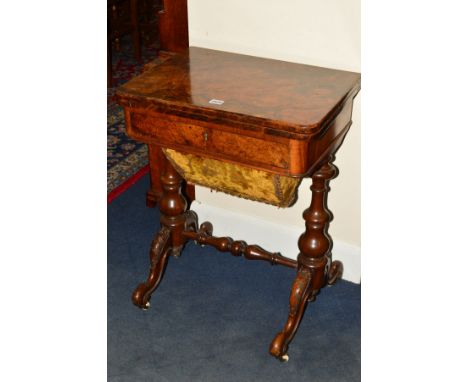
[125,100,352,177]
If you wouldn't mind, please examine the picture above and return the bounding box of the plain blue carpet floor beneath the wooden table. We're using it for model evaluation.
[107,176,361,382]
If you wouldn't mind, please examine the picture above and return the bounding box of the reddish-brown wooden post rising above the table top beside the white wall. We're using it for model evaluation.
[159,0,188,52]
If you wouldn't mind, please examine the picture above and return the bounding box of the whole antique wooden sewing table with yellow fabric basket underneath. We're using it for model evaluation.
[117,47,360,361]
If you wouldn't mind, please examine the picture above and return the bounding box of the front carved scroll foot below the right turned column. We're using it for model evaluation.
[270,268,312,361]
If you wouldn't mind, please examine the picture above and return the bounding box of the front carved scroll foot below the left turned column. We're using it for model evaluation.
[132,226,171,309]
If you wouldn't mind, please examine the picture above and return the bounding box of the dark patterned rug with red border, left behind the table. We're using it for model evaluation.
[107,38,158,203]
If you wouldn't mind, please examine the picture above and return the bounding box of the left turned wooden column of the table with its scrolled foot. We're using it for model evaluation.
[132,157,189,309]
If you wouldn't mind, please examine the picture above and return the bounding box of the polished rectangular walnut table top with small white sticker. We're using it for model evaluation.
[117,47,360,134]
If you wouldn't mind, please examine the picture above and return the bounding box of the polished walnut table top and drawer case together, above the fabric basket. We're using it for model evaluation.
[118,47,360,177]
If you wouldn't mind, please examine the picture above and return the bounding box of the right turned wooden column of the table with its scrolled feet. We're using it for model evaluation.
[270,157,343,361]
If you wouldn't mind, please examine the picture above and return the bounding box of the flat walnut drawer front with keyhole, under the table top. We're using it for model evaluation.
[126,110,290,171]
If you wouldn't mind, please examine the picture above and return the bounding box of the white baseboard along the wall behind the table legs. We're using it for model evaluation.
[190,201,361,283]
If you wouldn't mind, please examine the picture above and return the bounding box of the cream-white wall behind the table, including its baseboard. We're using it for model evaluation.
[188,0,361,281]
